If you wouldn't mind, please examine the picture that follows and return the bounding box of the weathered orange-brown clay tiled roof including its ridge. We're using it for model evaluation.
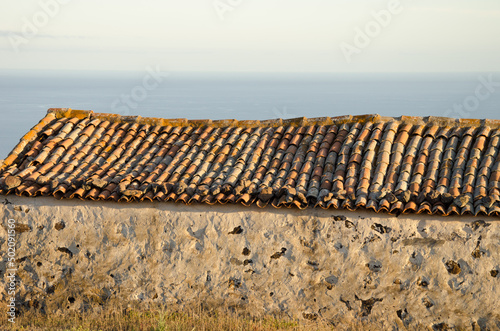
[0,109,500,216]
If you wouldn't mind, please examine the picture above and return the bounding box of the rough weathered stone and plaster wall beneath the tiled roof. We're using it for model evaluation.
[0,196,500,329]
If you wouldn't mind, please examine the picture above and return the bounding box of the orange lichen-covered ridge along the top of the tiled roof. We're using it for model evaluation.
[47,108,500,128]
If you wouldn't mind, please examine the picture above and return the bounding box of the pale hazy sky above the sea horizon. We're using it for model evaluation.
[0,0,500,72]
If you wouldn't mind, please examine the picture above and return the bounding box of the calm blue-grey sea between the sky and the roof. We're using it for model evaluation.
[0,72,500,159]
